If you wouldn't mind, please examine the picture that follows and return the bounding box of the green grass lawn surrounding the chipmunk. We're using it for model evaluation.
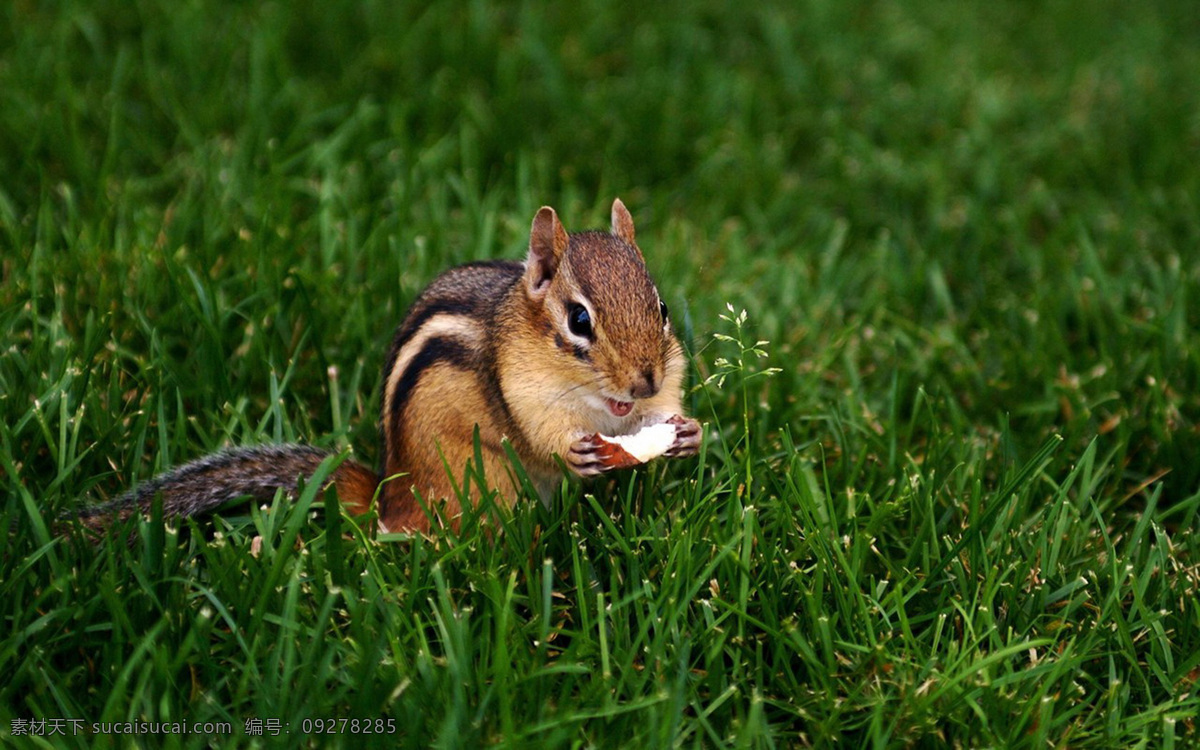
[0,0,1200,748]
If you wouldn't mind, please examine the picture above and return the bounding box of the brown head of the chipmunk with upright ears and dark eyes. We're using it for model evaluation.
[523,199,683,419]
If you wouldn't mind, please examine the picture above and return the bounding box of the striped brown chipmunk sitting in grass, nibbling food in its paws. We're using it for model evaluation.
[80,199,701,532]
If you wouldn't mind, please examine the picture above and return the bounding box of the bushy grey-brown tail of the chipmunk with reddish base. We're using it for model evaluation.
[78,445,379,530]
